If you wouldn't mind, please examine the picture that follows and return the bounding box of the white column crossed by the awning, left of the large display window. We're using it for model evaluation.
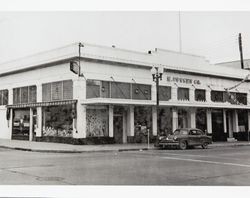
[36,84,43,137]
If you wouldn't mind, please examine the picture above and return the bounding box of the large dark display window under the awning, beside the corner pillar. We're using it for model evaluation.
[43,105,73,137]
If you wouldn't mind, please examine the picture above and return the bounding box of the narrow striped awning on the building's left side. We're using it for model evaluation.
[6,100,77,109]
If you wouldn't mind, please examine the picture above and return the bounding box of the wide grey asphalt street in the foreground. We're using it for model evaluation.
[0,146,250,186]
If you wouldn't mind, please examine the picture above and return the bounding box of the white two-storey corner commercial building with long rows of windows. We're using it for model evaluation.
[0,44,250,144]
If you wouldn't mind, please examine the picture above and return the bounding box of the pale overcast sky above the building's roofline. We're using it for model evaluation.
[0,11,250,63]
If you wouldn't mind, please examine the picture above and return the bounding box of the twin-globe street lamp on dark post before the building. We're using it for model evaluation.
[151,67,164,134]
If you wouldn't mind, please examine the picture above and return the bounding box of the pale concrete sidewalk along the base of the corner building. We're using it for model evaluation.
[0,139,250,153]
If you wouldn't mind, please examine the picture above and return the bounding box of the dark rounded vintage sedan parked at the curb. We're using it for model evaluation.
[155,128,212,150]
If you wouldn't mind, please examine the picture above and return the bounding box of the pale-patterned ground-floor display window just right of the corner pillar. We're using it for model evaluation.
[86,106,109,137]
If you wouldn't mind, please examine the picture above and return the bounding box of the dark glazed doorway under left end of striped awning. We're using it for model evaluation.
[12,109,30,140]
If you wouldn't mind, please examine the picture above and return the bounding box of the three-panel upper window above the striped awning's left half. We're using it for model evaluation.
[13,86,36,104]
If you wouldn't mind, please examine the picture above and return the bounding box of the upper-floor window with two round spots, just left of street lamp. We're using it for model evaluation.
[132,84,151,100]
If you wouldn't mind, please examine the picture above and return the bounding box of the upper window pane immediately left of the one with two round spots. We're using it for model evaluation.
[111,82,131,99]
